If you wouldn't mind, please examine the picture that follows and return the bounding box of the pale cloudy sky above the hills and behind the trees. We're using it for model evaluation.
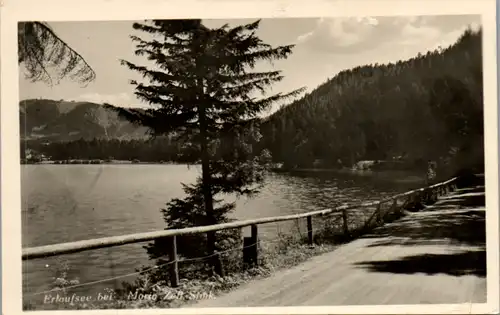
[19,15,480,112]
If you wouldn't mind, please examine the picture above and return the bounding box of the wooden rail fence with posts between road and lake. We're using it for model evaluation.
[22,177,457,287]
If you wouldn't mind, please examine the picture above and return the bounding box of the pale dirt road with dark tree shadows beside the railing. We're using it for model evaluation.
[190,187,486,307]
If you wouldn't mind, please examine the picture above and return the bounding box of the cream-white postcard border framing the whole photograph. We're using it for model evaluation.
[0,0,500,315]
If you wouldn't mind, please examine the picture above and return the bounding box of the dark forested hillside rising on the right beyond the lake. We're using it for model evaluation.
[262,29,483,178]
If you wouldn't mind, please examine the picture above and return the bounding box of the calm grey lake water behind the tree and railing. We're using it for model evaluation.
[22,165,422,303]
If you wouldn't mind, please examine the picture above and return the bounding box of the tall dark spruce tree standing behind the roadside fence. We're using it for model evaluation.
[110,20,301,274]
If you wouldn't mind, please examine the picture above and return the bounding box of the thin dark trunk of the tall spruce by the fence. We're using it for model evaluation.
[198,100,224,276]
